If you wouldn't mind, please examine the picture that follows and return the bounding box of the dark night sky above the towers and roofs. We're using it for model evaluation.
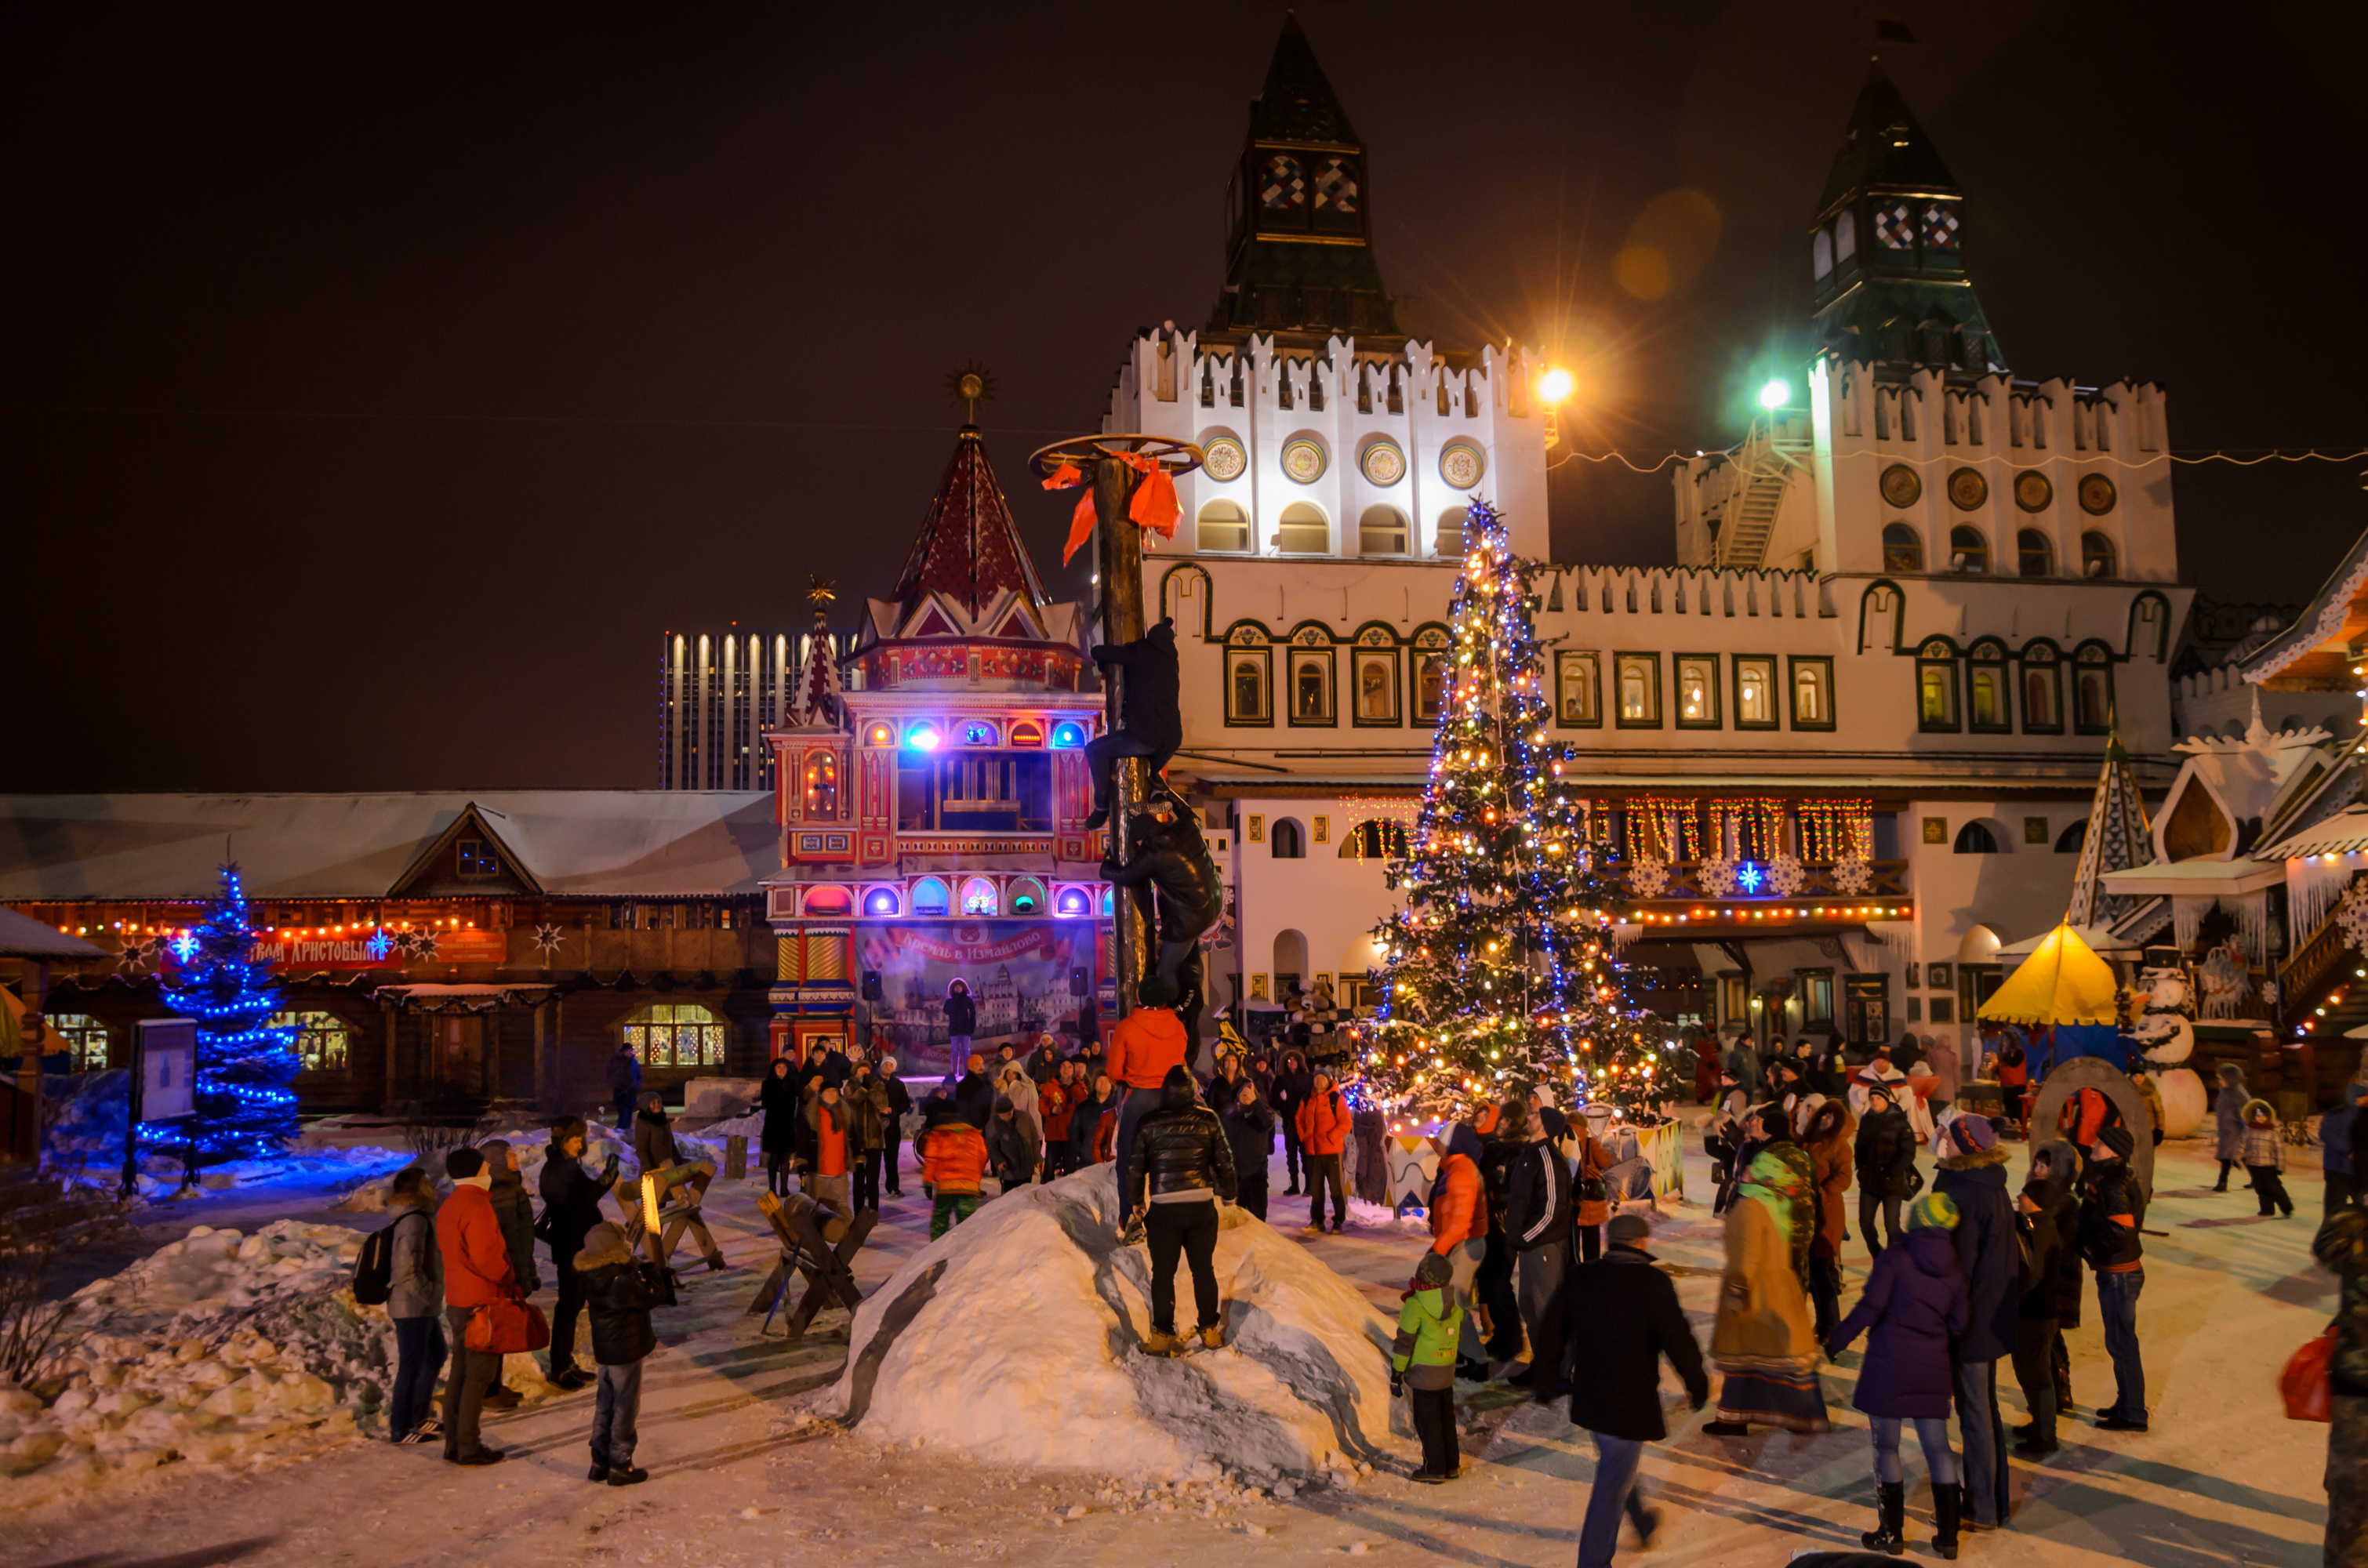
[0,0,2368,791]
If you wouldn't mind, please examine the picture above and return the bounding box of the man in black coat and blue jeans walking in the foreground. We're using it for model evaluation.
[1563,1215,1709,1563]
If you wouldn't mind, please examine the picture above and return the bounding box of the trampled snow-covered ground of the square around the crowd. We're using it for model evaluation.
[7,1144,2335,1568]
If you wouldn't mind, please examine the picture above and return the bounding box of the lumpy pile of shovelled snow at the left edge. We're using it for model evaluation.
[0,1220,557,1508]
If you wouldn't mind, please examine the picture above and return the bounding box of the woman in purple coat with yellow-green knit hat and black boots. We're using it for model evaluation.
[1825,1192,1968,1559]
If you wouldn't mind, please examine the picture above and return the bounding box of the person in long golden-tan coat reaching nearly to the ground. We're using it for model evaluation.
[1702,1151,1828,1438]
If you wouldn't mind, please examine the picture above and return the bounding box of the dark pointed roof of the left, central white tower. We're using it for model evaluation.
[1208,14,1397,339]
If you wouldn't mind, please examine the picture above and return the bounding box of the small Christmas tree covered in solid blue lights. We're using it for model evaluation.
[163,865,296,1160]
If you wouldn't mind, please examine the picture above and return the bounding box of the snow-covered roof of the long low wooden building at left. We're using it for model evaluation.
[0,789,782,902]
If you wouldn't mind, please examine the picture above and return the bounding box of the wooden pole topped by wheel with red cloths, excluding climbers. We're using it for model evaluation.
[1028,431,1203,1018]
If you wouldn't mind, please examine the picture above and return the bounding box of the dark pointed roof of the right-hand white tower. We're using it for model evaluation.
[1809,64,2006,381]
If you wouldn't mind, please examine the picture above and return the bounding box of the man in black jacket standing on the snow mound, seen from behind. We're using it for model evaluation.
[1120,1066,1238,1355]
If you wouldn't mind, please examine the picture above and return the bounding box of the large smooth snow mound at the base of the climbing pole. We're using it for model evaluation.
[808,1165,1411,1485]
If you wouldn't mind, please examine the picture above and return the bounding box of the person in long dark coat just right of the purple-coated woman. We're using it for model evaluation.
[1932,1116,2022,1530]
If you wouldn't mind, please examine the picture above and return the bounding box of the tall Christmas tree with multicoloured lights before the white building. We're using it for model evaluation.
[1359,502,1691,1118]
